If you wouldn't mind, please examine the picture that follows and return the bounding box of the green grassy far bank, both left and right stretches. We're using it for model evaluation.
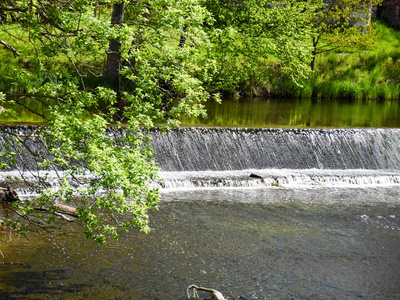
[0,22,400,100]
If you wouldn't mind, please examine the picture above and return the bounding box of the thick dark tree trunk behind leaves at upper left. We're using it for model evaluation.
[103,1,125,82]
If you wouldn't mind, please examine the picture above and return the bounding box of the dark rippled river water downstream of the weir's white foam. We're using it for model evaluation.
[0,188,400,300]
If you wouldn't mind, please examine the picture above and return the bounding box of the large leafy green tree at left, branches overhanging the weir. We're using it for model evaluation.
[0,0,213,243]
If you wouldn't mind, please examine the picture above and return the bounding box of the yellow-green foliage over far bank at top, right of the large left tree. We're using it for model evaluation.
[206,0,322,90]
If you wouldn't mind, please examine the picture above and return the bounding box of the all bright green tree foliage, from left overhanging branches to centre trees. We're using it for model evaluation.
[0,0,382,243]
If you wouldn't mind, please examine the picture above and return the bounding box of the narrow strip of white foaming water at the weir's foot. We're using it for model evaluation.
[155,169,400,190]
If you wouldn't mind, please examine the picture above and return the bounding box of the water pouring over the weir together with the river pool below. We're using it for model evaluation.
[0,128,400,300]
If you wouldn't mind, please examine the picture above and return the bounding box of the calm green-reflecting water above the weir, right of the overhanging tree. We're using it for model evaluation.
[182,99,400,128]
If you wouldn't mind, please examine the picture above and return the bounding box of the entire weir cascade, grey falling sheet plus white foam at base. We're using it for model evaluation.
[0,127,400,196]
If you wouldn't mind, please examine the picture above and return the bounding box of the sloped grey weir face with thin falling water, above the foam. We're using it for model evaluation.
[152,128,400,171]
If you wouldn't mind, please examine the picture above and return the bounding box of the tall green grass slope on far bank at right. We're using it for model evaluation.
[271,23,400,100]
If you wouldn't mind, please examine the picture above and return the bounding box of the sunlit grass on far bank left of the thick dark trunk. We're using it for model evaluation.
[0,24,109,94]
